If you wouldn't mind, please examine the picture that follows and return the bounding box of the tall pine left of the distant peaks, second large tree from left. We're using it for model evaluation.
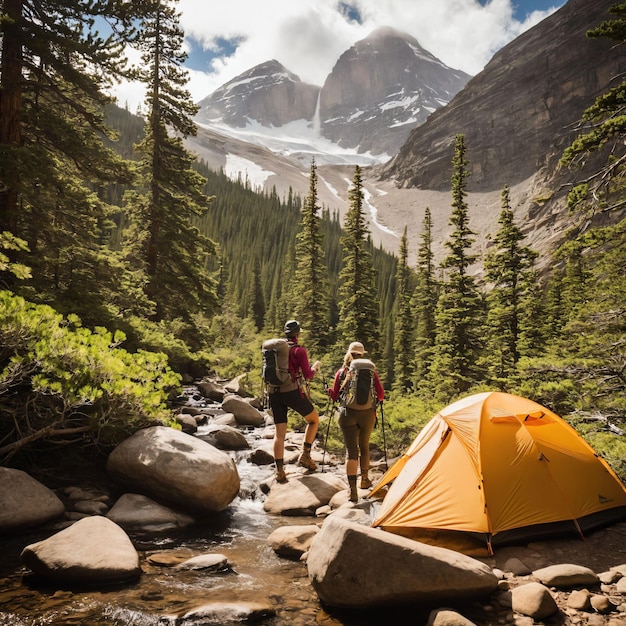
[125,0,217,322]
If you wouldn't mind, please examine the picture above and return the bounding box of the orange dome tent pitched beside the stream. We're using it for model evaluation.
[372,392,626,552]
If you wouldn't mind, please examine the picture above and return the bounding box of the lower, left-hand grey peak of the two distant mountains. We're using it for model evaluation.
[196,60,320,128]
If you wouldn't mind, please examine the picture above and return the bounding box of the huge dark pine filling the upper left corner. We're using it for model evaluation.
[0,0,145,324]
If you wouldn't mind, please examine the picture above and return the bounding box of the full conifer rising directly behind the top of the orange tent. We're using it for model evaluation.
[483,186,537,382]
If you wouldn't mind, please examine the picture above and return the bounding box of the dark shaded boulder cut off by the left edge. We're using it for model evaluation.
[0,467,65,533]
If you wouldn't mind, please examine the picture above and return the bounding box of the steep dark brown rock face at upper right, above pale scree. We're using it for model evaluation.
[383,0,626,190]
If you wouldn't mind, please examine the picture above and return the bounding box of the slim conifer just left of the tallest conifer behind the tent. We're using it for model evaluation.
[412,207,439,388]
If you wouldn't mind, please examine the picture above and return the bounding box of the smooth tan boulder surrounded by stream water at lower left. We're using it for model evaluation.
[20,516,141,585]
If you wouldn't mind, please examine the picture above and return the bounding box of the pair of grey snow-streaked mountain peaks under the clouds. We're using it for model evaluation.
[195,27,469,161]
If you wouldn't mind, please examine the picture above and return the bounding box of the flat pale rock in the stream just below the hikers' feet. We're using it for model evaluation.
[263,473,346,516]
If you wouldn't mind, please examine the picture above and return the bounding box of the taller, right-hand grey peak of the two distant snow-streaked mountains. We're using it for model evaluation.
[319,28,470,156]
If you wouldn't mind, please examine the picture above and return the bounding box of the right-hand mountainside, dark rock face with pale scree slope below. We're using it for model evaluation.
[184,0,626,267]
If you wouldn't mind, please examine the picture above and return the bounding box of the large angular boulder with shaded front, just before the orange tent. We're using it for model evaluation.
[307,515,498,608]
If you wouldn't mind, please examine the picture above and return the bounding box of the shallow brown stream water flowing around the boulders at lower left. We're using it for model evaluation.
[0,390,408,626]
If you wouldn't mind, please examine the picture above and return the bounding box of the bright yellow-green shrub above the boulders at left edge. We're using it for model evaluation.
[0,291,180,459]
